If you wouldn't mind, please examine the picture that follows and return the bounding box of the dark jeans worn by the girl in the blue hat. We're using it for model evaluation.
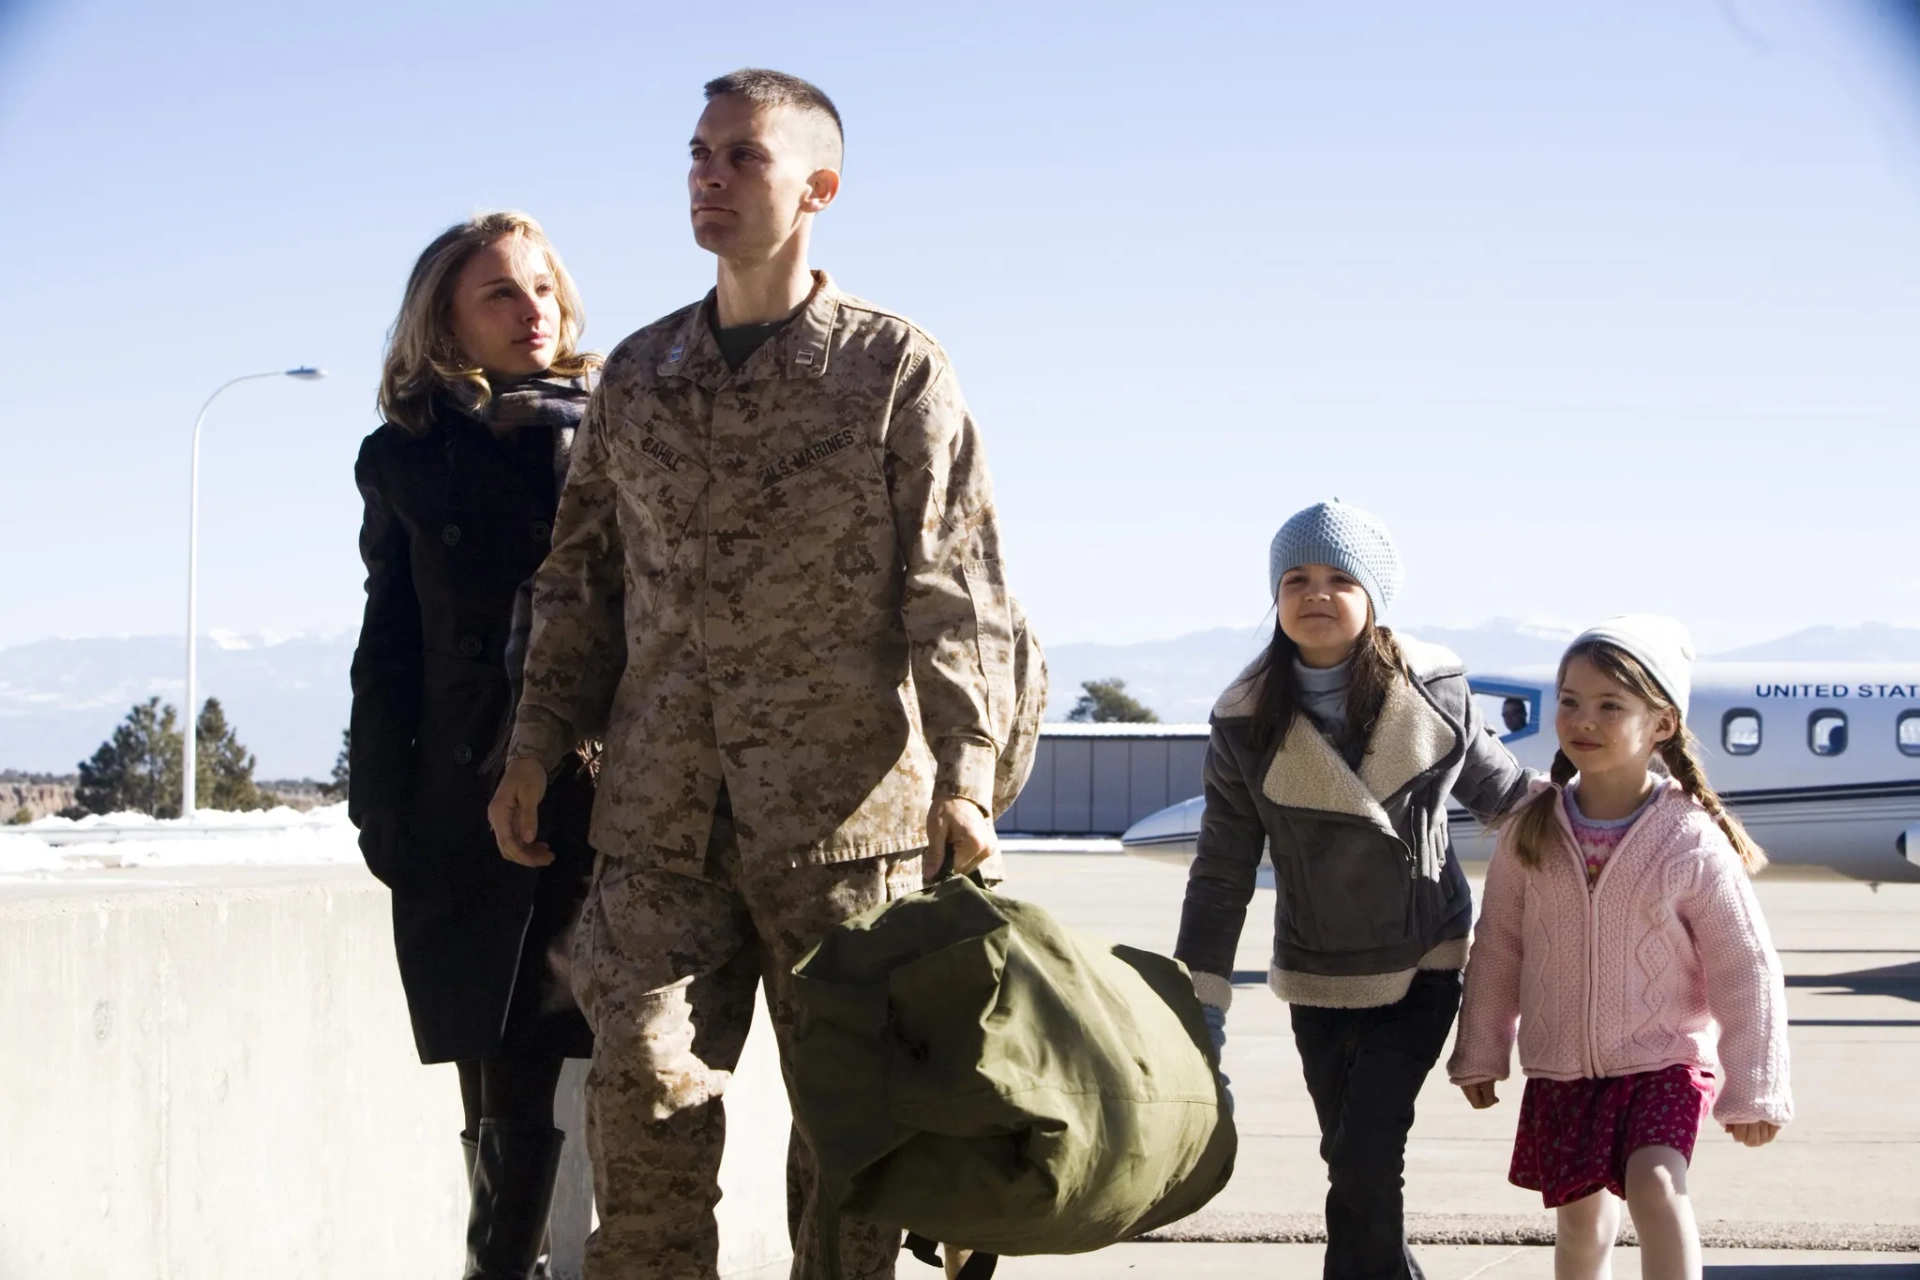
[1292,969,1459,1280]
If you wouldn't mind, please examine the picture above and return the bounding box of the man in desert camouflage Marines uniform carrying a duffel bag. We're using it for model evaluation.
[492,71,1014,1280]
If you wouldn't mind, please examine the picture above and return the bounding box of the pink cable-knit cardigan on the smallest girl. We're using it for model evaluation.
[1448,783,1793,1125]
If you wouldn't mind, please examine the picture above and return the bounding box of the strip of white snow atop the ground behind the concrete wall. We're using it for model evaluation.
[0,804,361,877]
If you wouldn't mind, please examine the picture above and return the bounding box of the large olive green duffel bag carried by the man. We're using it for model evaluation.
[791,879,1236,1276]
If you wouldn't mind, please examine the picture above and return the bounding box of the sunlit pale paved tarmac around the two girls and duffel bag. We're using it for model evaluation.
[975,852,1920,1280]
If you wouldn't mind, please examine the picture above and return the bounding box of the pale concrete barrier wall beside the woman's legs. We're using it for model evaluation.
[0,867,787,1280]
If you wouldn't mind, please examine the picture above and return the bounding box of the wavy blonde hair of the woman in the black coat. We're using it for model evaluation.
[380,209,601,436]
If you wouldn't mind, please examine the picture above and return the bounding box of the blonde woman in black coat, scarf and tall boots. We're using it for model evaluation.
[348,213,599,1280]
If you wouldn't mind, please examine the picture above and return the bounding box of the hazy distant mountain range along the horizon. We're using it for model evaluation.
[0,618,1920,779]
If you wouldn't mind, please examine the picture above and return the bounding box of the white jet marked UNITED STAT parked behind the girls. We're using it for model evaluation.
[1121,662,1920,883]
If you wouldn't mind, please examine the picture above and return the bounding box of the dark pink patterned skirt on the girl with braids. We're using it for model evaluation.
[1507,1065,1718,1209]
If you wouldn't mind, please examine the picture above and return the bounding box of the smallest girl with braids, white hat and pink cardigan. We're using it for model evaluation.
[1448,614,1793,1280]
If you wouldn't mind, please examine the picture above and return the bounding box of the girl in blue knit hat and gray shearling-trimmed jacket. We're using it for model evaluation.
[1175,501,1530,1280]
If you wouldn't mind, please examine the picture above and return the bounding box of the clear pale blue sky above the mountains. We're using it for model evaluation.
[0,0,1920,649]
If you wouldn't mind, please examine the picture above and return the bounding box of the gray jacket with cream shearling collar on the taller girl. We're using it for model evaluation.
[1175,635,1534,1007]
